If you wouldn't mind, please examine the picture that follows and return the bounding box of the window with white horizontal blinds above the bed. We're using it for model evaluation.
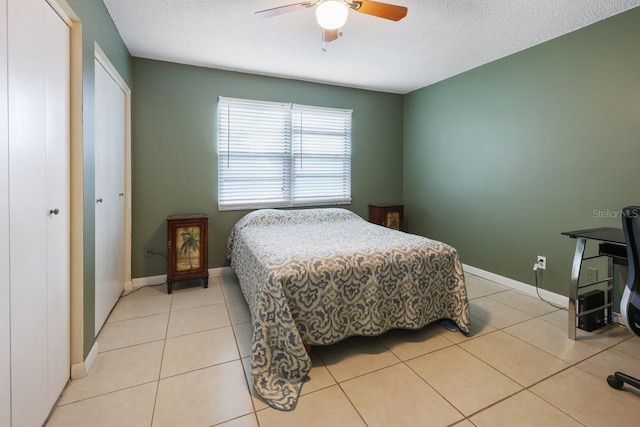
[218,97,352,210]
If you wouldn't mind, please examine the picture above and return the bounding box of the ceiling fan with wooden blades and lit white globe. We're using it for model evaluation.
[256,0,407,42]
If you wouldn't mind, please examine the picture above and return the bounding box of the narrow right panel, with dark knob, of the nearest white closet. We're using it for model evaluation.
[45,5,71,407]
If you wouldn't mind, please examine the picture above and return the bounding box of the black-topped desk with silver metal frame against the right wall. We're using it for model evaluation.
[562,227,627,340]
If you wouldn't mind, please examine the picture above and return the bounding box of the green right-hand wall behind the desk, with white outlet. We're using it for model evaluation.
[404,8,640,295]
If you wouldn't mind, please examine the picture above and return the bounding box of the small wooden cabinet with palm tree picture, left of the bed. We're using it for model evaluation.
[167,215,209,293]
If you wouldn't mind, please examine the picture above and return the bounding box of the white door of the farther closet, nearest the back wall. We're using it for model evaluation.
[95,59,125,335]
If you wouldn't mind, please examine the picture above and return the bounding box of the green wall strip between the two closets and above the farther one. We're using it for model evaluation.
[66,0,132,357]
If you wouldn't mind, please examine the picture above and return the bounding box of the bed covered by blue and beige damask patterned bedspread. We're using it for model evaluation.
[227,208,469,410]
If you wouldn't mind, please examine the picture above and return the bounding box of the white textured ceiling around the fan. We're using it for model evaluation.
[104,0,640,94]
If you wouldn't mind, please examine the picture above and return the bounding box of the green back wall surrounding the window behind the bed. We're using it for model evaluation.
[132,58,403,277]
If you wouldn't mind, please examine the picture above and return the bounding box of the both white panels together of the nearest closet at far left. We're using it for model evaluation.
[7,0,70,427]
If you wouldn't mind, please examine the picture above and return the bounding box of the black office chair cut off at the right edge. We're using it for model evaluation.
[607,206,640,389]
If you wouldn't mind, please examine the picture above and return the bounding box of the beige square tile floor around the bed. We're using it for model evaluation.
[47,273,640,427]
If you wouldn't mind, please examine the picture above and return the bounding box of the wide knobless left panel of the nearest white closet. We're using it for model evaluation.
[8,0,49,427]
